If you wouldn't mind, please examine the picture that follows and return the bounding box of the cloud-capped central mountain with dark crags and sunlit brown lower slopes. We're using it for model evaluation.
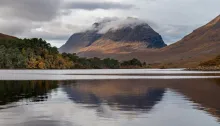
[59,18,166,54]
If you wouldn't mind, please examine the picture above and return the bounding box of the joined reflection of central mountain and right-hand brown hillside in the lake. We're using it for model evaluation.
[62,79,220,119]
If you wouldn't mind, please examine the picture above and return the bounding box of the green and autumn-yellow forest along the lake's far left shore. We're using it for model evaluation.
[0,38,146,69]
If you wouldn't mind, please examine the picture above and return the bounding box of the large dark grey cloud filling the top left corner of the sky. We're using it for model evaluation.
[0,0,61,21]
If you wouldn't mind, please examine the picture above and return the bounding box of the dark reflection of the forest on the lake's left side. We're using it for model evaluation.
[0,81,58,105]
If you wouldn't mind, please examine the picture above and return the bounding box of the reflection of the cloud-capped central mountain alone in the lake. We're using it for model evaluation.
[62,80,166,111]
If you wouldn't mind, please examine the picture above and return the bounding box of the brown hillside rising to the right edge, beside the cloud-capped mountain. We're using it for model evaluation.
[161,15,220,66]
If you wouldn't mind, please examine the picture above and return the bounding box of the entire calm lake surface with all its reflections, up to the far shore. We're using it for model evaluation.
[0,69,220,126]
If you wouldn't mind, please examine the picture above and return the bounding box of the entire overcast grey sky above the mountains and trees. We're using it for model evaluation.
[0,0,220,47]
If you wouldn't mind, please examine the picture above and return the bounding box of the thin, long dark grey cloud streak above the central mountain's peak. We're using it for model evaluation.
[64,1,134,10]
